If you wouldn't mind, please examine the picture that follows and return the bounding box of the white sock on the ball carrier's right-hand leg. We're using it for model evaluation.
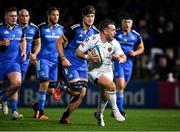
[107,91,118,110]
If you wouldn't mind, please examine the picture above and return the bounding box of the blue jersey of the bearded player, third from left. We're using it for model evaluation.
[38,22,64,62]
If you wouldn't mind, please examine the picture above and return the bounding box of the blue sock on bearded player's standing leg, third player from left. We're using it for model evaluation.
[38,91,46,111]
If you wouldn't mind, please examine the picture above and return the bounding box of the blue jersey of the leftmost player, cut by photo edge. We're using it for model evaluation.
[0,23,25,62]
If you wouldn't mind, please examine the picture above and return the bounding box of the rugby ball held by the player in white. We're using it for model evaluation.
[91,45,106,63]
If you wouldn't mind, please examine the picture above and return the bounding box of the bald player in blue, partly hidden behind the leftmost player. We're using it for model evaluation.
[3,9,41,117]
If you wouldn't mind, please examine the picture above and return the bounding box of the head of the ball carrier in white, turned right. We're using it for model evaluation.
[105,24,116,42]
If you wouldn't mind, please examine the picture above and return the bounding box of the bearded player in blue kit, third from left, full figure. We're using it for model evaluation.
[33,7,64,120]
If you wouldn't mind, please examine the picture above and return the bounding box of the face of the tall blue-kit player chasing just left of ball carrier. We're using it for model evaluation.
[83,14,95,27]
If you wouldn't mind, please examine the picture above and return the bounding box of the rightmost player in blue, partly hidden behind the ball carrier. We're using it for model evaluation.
[114,17,144,116]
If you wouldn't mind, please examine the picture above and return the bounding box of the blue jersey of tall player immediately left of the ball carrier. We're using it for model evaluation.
[63,24,99,69]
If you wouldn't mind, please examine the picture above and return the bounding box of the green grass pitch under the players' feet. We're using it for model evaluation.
[0,108,180,131]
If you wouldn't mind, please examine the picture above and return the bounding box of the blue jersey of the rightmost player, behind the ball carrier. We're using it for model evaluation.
[115,29,144,59]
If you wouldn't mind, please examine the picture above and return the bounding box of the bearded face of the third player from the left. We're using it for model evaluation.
[49,10,59,25]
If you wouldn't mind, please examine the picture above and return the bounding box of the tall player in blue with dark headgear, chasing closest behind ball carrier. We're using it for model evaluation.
[57,5,98,124]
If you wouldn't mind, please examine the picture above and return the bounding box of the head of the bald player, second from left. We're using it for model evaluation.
[19,10,30,25]
